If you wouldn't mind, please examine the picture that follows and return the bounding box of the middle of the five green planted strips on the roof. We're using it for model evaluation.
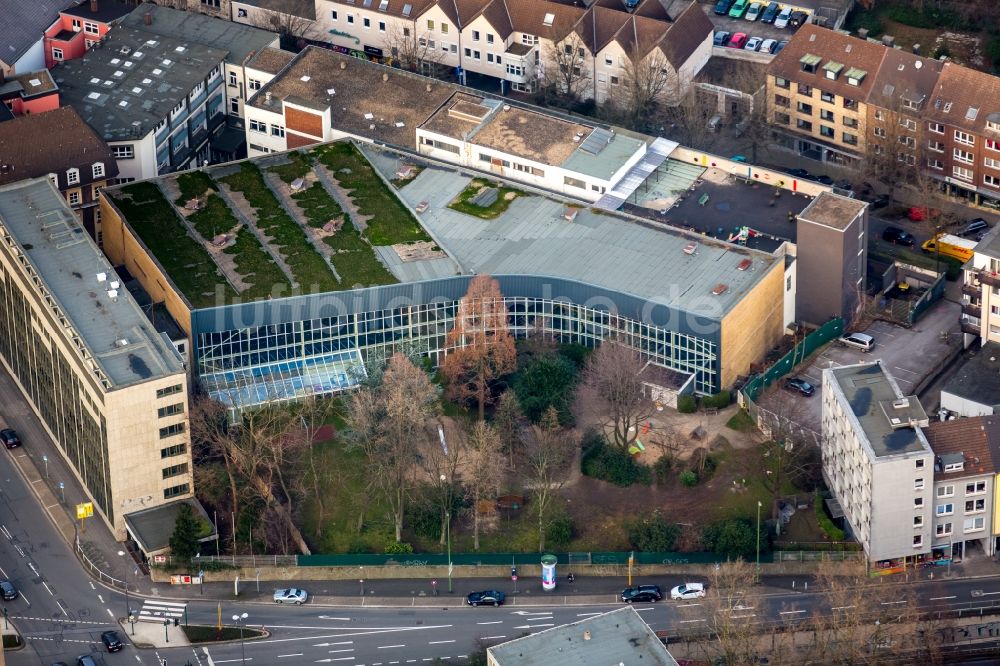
[222,162,339,291]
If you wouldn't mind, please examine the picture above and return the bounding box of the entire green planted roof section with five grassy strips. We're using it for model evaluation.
[109,142,414,308]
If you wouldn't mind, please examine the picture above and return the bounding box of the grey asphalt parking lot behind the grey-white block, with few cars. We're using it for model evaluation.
[757,300,962,432]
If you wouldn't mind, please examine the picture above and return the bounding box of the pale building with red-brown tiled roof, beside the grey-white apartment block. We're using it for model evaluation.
[924,417,1000,559]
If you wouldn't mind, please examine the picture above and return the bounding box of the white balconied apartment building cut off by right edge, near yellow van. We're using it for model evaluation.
[961,226,1000,347]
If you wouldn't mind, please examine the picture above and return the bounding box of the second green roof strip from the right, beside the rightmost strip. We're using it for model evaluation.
[292,183,397,288]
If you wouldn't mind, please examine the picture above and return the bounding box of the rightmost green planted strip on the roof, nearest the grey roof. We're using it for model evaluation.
[313,141,430,245]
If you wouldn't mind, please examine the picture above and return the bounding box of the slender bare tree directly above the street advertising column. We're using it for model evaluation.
[525,407,578,552]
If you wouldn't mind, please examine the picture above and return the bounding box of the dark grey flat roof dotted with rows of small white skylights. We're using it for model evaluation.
[52,26,231,141]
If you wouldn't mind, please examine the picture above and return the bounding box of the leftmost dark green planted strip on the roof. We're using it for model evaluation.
[115,182,236,308]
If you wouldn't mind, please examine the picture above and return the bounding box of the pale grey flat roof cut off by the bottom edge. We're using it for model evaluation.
[489,606,677,666]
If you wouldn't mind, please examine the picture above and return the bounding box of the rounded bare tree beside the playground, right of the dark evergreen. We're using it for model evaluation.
[583,340,653,449]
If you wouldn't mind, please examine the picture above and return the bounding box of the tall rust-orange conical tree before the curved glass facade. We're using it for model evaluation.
[441,275,517,420]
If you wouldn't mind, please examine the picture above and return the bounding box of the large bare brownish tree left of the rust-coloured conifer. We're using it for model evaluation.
[348,353,437,541]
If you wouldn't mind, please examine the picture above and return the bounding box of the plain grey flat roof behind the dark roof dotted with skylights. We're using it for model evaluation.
[122,3,278,65]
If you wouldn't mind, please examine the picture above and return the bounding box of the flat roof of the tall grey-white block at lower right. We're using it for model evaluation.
[824,361,931,458]
